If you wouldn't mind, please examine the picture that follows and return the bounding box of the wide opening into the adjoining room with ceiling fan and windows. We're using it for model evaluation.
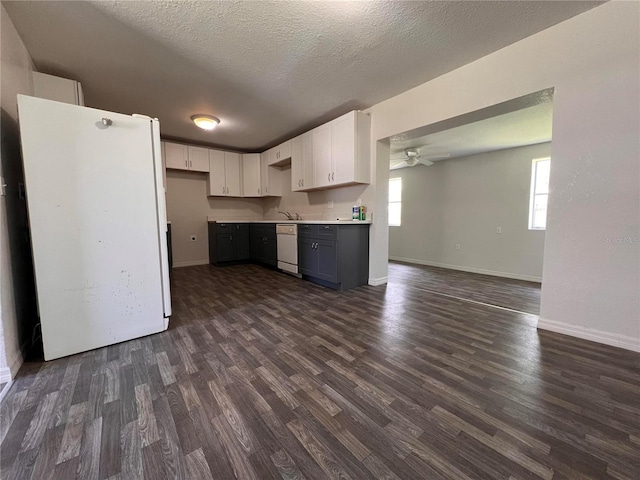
[389,88,553,315]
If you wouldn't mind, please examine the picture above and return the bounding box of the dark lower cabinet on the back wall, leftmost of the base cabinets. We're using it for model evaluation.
[209,222,251,265]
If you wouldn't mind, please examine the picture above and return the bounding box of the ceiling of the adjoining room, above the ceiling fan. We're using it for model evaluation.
[391,102,553,167]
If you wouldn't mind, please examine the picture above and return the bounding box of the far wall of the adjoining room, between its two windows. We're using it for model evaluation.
[389,143,551,281]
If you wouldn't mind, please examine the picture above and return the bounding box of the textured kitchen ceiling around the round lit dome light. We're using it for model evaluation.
[3,0,601,150]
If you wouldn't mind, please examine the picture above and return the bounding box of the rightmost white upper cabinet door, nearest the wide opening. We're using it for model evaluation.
[331,112,356,184]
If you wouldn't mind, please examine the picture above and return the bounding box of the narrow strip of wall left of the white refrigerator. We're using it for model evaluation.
[0,6,34,382]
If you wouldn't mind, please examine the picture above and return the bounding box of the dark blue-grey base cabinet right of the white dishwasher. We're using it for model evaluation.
[298,224,369,290]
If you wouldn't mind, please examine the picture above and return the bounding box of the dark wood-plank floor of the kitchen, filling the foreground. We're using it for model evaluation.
[0,264,640,480]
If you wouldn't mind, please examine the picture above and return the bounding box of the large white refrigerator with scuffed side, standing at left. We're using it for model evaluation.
[18,95,171,360]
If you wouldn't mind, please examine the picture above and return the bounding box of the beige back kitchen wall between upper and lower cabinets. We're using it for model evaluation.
[167,170,263,267]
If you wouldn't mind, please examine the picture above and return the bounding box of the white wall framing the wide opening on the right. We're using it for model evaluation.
[362,2,640,351]
